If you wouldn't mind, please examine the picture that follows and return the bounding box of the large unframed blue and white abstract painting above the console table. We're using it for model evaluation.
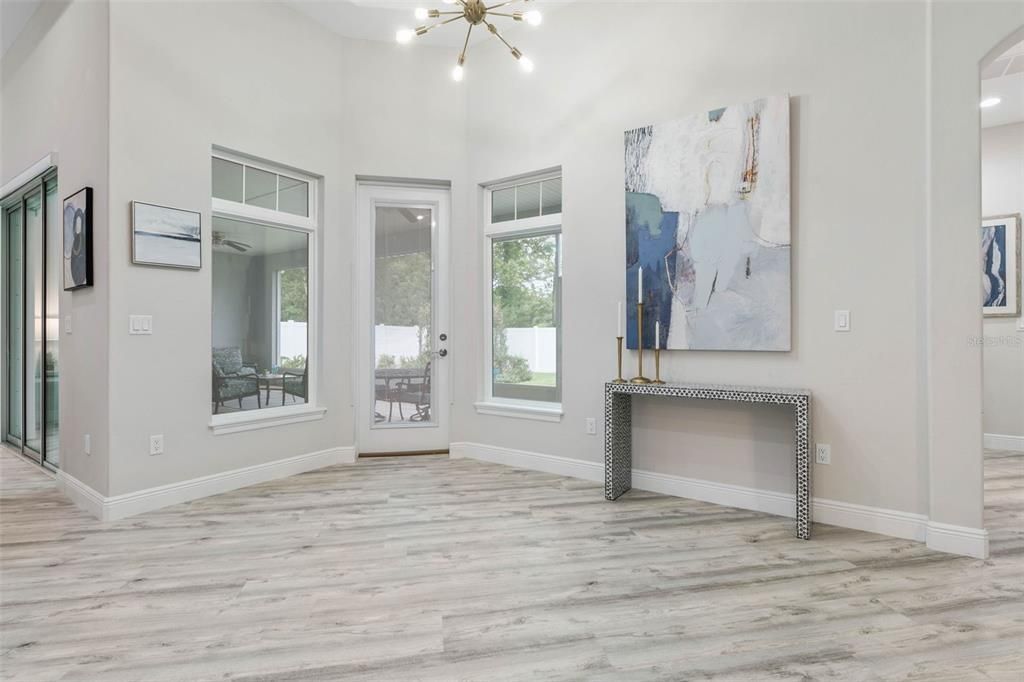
[626,95,791,350]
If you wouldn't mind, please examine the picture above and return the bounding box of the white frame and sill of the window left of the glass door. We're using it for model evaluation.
[210,146,319,435]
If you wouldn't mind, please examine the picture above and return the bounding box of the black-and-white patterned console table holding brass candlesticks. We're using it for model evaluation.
[604,382,811,540]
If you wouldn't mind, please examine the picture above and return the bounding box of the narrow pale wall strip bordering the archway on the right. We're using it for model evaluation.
[918,6,1024,532]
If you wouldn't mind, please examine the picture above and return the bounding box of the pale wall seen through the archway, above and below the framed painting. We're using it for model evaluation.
[981,123,1024,442]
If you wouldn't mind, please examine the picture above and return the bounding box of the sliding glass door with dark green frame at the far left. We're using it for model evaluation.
[2,173,60,467]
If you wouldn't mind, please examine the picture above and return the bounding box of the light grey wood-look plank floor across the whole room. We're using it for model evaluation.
[0,453,1024,682]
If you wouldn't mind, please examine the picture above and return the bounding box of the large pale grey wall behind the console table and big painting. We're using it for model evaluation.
[453,2,1007,527]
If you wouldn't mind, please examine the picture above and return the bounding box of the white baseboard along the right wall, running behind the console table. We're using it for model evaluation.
[451,442,937,544]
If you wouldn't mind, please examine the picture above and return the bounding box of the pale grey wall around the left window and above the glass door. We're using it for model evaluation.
[102,1,465,495]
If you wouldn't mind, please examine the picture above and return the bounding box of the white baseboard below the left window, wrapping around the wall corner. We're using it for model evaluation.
[57,446,355,521]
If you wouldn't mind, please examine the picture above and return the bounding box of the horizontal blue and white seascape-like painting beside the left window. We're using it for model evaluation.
[131,202,203,270]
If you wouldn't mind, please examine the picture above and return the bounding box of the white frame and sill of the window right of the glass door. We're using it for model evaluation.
[474,168,565,422]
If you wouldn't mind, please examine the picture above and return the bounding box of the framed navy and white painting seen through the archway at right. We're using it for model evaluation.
[981,213,1021,317]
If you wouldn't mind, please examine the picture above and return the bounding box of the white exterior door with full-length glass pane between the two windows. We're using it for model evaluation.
[357,185,450,454]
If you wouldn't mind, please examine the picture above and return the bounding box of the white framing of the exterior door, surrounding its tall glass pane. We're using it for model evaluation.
[352,178,452,456]
